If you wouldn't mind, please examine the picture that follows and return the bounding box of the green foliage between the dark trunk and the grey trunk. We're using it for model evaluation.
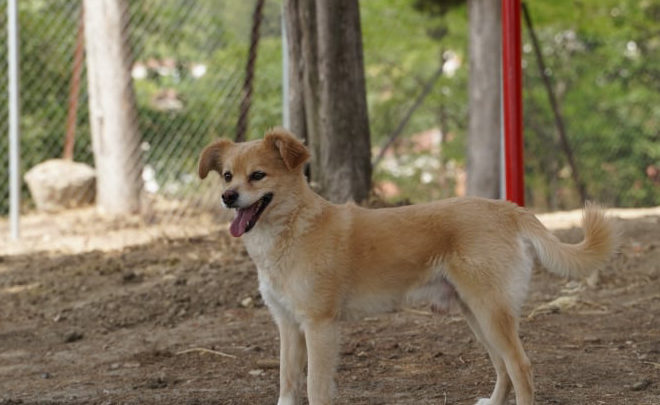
[360,0,468,201]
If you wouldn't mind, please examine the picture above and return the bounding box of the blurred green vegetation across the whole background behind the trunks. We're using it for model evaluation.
[0,0,660,213]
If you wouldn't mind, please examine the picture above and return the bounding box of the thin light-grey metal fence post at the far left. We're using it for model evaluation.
[7,0,21,240]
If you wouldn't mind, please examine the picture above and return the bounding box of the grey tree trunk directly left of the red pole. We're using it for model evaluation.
[467,0,502,198]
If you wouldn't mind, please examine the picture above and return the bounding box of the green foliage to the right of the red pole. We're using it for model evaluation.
[524,0,660,207]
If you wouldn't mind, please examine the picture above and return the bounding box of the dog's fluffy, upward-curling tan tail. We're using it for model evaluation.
[519,204,618,277]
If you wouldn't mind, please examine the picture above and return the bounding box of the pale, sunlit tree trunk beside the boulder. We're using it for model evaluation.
[84,0,142,214]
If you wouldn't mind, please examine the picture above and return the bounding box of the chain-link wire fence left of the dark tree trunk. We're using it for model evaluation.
[0,0,282,248]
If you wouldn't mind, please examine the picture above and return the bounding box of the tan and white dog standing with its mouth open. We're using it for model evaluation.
[199,129,615,405]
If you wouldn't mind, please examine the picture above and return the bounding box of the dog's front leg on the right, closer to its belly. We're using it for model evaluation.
[305,320,339,405]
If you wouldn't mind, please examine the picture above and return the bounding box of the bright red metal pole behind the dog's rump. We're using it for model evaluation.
[502,0,525,206]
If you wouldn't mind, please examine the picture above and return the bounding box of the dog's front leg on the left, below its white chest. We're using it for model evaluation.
[277,317,306,405]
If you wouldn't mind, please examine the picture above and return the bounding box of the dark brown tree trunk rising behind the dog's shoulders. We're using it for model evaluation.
[286,0,371,202]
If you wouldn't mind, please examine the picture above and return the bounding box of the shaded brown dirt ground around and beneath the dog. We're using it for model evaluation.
[0,210,660,405]
